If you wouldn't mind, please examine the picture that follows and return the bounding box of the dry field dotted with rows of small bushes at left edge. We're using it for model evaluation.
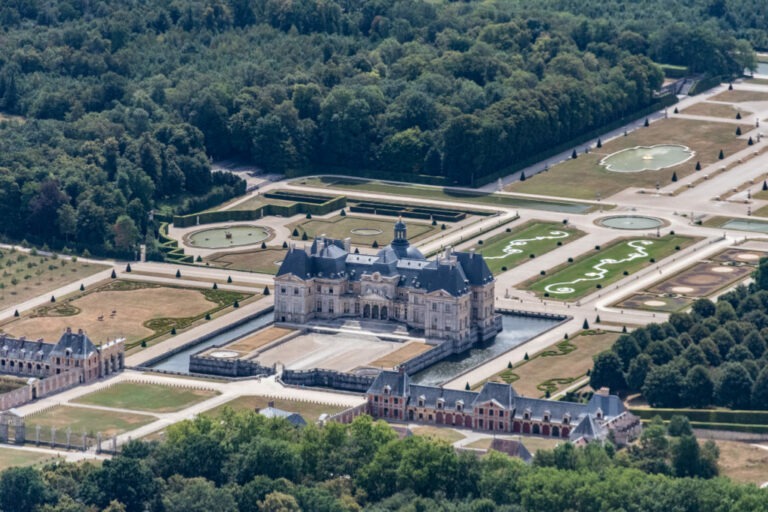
[0,249,109,309]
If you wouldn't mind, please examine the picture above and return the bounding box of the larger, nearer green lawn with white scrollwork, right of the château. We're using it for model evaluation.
[523,235,695,300]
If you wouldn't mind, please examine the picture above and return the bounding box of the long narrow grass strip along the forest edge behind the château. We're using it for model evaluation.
[291,176,594,213]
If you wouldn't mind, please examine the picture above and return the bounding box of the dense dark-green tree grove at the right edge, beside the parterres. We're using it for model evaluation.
[590,259,768,410]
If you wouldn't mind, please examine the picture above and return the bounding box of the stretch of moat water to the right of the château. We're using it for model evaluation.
[411,315,560,386]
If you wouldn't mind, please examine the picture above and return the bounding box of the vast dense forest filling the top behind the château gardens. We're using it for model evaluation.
[0,0,765,254]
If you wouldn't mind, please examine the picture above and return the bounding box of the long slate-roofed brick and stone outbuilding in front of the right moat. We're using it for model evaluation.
[366,371,642,444]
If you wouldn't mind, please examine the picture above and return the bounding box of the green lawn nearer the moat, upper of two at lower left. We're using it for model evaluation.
[74,382,219,412]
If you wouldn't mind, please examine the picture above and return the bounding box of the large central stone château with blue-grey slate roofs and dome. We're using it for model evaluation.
[274,221,501,352]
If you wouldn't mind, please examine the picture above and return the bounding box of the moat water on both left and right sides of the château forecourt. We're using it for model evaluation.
[152,313,560,385]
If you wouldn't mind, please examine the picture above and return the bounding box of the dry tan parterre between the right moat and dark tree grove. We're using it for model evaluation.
[489,331,619,397]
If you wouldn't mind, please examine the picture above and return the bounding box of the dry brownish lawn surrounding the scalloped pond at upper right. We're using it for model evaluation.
[507,118,751,199]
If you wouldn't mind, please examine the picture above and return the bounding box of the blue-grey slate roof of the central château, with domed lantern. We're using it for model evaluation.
[277,221,493,296]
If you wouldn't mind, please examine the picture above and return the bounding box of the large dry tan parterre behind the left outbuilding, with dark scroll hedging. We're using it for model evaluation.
[0,280,247,344]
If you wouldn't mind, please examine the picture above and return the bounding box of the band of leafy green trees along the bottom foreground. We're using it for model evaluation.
[0,410,768,512]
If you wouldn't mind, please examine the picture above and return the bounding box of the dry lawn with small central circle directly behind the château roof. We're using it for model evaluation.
[287,215,440,247]
